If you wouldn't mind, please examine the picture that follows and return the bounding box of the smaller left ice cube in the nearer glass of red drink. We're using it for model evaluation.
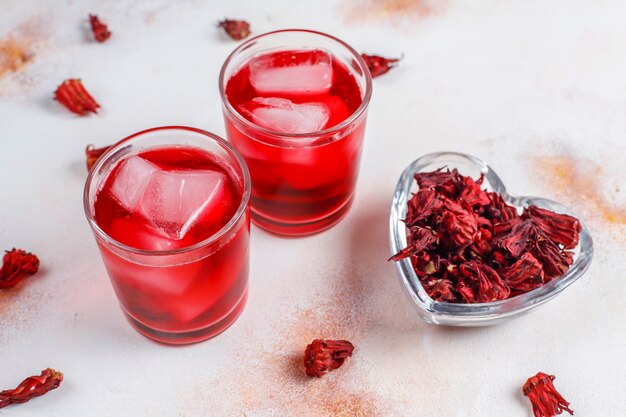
[111,156,157,212]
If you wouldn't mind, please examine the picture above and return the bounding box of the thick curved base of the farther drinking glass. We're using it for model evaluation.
[251,196,353,237]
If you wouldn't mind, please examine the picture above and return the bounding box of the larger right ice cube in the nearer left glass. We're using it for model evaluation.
[141,170,227,240]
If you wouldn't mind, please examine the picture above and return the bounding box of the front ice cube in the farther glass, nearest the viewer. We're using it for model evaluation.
[240,97,330,133]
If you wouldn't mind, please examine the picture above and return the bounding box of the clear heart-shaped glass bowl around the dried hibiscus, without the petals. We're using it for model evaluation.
[389,152,593,327]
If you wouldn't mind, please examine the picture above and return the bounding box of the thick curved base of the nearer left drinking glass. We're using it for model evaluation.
[122,288,248,345]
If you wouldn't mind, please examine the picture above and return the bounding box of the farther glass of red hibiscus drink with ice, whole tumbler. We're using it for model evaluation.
[220,30,372,236]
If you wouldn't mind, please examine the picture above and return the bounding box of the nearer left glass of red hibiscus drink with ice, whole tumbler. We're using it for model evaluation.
[85,127,250,344]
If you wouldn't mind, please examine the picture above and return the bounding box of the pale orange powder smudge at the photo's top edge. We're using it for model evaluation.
[345,0,443,21]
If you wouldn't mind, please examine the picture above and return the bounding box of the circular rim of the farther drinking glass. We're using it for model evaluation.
[218,29,372,141]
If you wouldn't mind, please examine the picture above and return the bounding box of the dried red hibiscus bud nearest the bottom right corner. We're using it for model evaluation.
[522,372,574,417]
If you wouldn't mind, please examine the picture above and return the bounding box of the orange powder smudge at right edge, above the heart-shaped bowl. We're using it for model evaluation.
[533,154,626,225]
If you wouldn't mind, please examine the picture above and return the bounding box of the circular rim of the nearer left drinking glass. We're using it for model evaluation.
[83,125,252,256]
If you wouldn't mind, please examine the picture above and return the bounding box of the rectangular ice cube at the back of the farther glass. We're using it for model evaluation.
[250,50,333,96]
